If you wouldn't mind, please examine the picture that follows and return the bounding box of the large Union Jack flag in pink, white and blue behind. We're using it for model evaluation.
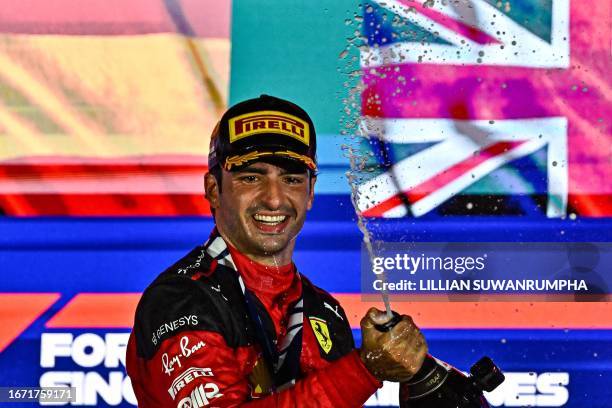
[357,0,612,218]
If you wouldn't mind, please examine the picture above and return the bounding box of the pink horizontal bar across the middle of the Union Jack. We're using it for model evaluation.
[362,63,612,120]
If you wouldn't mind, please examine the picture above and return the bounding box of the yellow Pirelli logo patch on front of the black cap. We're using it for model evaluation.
[229,111,310,146]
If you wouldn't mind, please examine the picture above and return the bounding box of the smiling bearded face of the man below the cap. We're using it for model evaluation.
[206,162,316,265]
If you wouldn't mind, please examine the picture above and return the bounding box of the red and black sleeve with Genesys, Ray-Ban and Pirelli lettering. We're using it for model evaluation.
[126,279,256,408]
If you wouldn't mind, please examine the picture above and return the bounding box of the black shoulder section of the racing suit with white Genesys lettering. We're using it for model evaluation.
[133,242,254,359]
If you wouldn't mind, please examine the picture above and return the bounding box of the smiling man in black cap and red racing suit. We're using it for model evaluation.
[127,95,427,408]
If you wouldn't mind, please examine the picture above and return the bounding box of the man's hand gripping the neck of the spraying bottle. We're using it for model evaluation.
[360,307,427,382]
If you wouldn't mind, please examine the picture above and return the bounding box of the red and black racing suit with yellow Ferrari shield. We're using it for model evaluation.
[126,232,382,408]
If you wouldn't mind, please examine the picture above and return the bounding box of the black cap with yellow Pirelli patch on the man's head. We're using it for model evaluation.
[208,95,317,171]
